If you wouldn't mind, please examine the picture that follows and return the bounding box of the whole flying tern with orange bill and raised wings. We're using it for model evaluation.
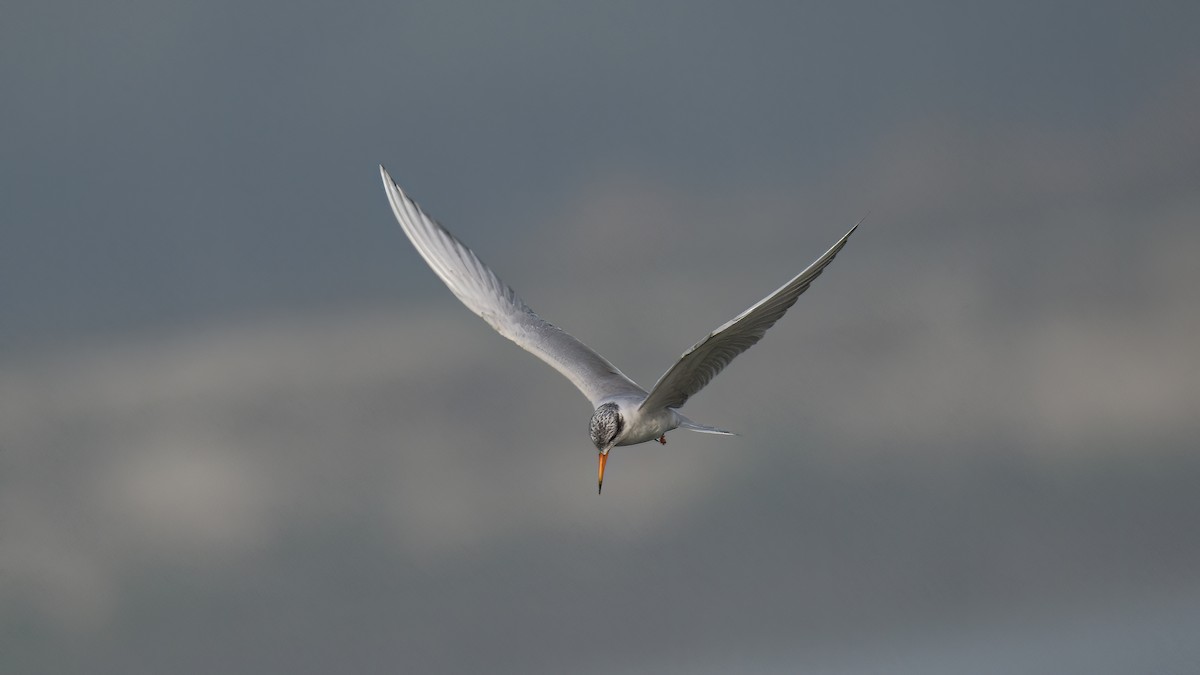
[379,165,866,494]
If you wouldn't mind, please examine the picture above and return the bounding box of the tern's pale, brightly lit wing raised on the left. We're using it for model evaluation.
[379,166,646,406]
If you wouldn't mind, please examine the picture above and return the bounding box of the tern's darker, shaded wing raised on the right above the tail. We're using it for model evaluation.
[640,221,863,411]
